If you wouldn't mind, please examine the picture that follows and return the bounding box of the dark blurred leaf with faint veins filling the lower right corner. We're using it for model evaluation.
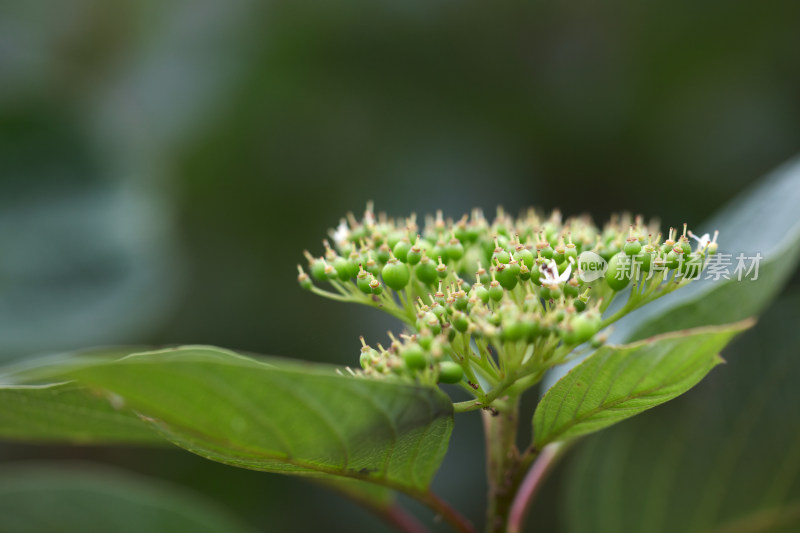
[562,293,800,533]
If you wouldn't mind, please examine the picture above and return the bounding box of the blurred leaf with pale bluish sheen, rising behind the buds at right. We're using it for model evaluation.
[614,152,800,341]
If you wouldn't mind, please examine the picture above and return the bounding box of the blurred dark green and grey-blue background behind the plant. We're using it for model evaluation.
[0,0,800,531]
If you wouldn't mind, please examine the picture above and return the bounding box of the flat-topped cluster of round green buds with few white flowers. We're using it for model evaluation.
[298,206,717,408]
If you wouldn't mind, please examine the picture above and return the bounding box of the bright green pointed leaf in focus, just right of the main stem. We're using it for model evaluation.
[533,321,753,449]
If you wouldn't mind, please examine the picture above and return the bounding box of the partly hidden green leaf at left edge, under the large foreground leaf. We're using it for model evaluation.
[0,383,165,445]
